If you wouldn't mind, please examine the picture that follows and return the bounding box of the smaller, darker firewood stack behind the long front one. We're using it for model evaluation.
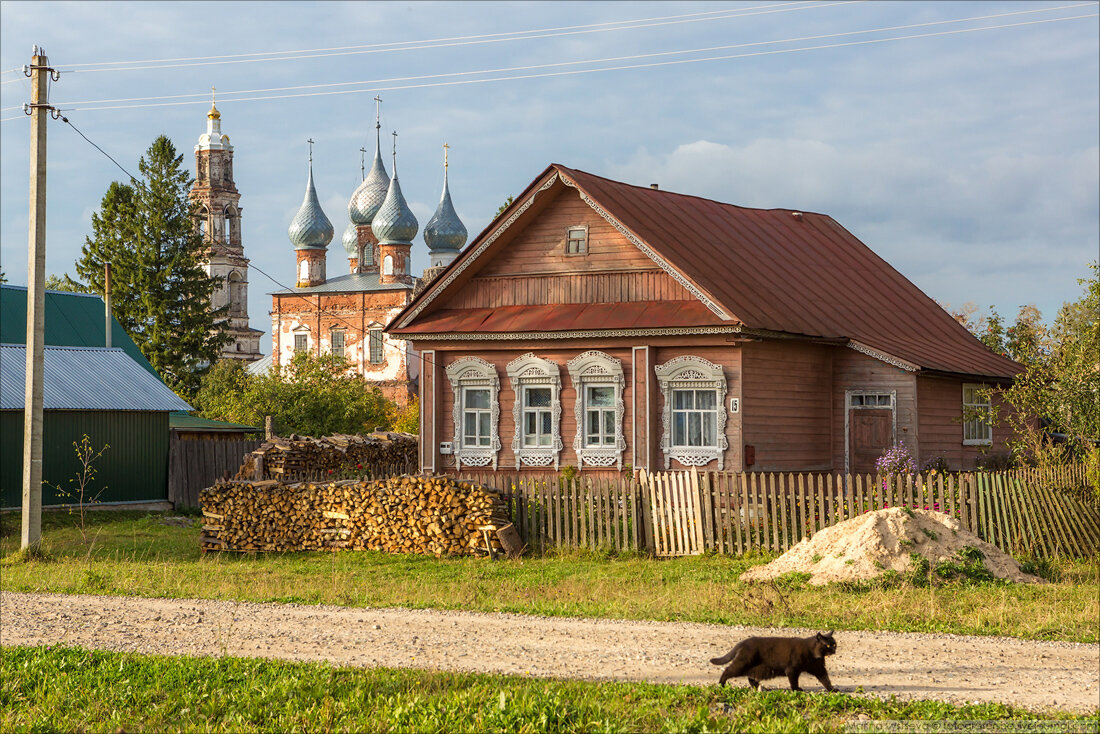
[237,430,419,480]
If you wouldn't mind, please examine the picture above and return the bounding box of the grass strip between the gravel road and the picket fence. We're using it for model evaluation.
[0,512,1100,643]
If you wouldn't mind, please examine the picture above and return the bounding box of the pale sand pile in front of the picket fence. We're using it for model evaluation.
[740,507,1043,584]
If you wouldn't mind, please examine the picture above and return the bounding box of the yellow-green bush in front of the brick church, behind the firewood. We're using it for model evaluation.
[195,352,396,436]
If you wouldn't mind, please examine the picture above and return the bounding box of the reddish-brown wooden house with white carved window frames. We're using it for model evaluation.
[387,164,1021,472]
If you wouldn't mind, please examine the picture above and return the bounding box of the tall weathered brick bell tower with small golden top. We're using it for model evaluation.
[190,87,263,362]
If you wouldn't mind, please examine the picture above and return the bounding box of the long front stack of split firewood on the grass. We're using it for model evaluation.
[199,475,514,556]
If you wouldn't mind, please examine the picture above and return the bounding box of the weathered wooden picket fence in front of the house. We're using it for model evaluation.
[461,467,1100,557]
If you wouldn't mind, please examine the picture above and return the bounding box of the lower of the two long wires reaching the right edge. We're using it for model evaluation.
[27,13,1100,116]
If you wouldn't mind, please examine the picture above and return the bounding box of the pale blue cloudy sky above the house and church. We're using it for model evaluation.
[0,0,1100,353]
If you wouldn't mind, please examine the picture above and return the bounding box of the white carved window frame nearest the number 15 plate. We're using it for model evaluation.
[653,355,729,471]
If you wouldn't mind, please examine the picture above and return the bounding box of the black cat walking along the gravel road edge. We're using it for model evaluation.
[711,629,836,691]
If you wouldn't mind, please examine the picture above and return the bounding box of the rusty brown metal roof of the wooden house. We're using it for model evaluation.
[391,164,1022,377]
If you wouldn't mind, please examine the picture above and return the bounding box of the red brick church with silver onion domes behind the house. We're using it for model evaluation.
[271,108,466,407]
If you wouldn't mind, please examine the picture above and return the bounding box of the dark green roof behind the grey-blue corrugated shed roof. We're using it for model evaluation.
[0,285,163,382]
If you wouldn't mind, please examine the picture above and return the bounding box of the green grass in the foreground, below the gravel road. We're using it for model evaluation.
[0,647,1097,732]
